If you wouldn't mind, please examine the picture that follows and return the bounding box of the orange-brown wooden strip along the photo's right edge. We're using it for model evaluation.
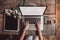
[56,0,60,40]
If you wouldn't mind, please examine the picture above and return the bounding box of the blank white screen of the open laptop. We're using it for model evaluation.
[20,7,46,15]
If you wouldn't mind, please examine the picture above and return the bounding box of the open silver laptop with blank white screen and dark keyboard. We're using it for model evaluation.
[20,7,46,30]
